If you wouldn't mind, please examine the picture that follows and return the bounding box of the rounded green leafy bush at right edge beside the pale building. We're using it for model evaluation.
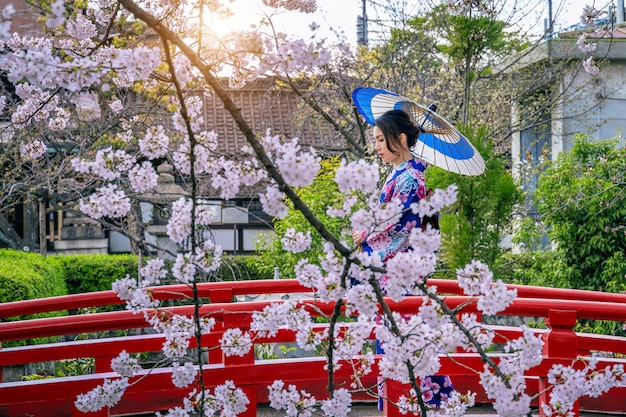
[537,135,626,290]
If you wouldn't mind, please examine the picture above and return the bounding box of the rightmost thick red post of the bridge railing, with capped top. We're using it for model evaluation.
[539,309,580,417]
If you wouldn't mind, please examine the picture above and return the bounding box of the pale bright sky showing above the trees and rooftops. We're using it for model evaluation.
[218,0,584,45]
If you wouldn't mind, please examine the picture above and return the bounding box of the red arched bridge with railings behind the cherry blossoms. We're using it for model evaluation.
[0,280,626,417]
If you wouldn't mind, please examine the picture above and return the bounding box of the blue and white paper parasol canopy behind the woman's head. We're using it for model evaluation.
[352,87,485,175]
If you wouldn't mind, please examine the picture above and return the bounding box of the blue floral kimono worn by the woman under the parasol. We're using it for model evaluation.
[361,159,453,410]
